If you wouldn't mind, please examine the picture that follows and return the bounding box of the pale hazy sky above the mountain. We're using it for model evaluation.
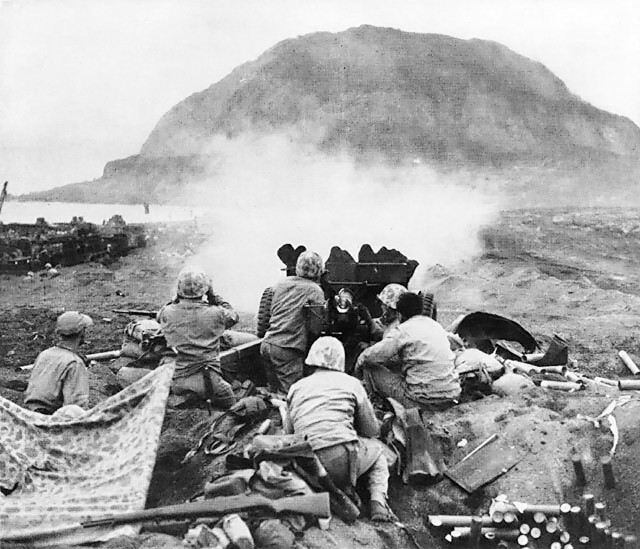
[0,0,640,194]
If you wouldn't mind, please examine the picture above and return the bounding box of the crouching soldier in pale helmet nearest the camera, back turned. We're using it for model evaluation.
[285,336,390,520]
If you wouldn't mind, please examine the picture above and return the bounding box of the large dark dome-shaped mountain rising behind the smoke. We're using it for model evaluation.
[23,26,640,201]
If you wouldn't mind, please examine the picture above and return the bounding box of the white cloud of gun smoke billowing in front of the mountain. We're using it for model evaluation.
[176,135,499,312]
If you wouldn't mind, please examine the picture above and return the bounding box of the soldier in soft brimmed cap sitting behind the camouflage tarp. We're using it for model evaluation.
[24,311,93,415]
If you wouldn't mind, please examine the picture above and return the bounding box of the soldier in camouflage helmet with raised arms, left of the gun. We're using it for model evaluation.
[157,267,257,409]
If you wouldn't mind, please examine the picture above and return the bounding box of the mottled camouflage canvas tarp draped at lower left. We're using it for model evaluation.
[0,362,175,546]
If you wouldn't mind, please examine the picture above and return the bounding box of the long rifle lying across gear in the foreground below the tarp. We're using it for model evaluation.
[81,492,331,528]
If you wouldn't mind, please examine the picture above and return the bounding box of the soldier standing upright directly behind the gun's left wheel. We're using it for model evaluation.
[260,251,325,393]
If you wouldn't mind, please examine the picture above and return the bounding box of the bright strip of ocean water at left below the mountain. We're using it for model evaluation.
[0,200,207,225]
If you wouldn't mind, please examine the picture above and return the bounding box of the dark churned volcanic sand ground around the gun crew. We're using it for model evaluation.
[0,209,640,548]
